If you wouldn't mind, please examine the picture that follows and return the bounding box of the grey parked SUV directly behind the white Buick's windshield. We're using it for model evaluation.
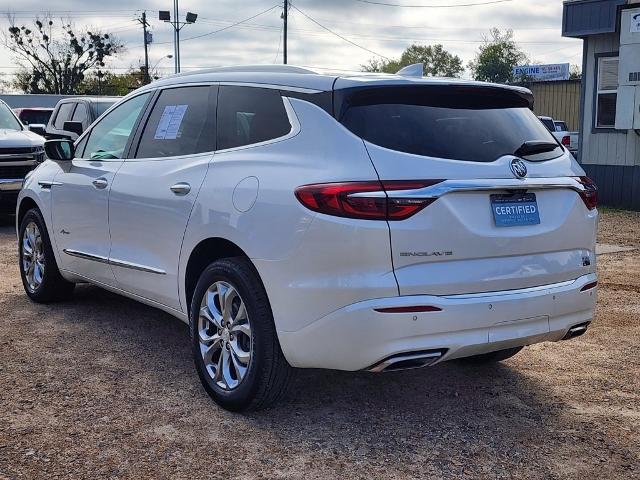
[45,97,120,140]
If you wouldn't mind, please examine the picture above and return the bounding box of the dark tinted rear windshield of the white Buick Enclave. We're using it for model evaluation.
[336,85,563,162]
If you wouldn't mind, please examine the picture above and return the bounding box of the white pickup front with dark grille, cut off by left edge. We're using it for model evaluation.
[0,100,44,214]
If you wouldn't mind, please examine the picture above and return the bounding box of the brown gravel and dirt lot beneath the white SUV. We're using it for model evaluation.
[0,211,640,480]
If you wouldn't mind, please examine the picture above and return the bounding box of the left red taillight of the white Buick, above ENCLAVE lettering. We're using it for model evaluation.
[295,180,442,220]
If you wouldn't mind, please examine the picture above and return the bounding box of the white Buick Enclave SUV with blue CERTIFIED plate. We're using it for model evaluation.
[17,66,597,411]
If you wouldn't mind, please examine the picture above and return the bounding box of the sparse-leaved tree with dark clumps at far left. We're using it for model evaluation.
[3,17,124,94]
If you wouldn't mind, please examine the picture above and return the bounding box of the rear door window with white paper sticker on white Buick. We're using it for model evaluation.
[136,86,218,158]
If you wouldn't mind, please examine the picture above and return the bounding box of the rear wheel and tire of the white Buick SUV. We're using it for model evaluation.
[189,257,293,412]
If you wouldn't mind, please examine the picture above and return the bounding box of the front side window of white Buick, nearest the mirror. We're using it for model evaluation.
[82,93,151,159]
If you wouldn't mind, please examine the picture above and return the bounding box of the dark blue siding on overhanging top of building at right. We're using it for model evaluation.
[562,0,627,37]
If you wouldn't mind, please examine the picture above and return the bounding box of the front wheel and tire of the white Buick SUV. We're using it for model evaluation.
[18,208,75,303]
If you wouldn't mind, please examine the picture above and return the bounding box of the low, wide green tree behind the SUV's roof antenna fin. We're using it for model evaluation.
[362,43,464,77]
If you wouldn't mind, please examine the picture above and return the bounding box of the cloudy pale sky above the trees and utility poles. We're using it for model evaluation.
[0,0,582,79]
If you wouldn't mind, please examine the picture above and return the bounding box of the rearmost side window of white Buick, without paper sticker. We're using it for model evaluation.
[218,86,291,150]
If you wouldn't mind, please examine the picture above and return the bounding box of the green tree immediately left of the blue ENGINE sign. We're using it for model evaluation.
[469,28,529,83]
